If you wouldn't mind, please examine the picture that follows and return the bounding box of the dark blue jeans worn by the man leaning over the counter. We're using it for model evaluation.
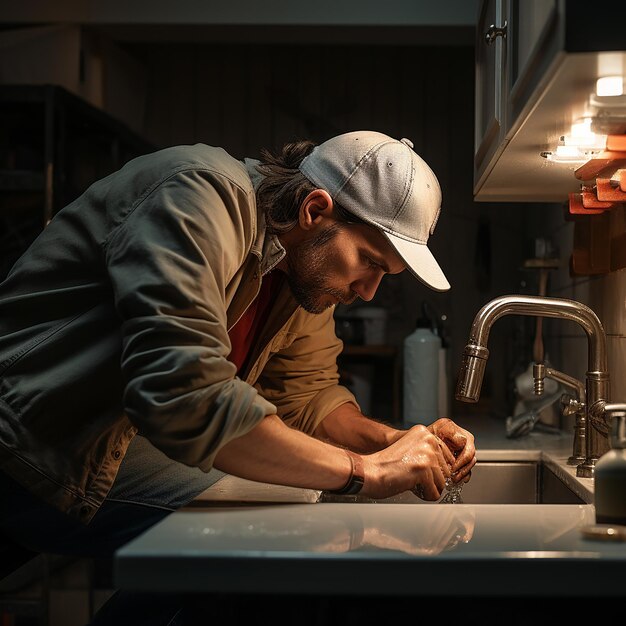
[0,435,224,626]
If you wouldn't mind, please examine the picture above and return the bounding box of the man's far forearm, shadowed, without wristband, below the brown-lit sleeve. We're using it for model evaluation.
[313,402,404,454]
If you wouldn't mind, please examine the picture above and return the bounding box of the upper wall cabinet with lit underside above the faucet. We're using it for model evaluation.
[474,0,626,202]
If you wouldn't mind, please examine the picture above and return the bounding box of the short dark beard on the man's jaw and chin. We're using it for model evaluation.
[287,224,358,314]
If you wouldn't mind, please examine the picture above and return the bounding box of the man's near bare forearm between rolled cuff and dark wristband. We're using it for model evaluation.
[214,415,352,490]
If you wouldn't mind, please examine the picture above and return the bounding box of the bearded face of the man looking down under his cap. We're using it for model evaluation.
[286,220,405,313]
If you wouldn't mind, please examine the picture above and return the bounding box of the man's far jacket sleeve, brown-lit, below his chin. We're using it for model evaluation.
[257,309,359,434]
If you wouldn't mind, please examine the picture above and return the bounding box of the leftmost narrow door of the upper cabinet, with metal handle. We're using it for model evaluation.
[474,0,507,192]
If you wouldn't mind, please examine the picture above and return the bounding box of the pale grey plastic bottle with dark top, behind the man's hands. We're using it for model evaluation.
[403,316,441,428]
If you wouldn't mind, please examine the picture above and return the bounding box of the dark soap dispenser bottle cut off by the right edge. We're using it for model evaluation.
[594,404,626,524]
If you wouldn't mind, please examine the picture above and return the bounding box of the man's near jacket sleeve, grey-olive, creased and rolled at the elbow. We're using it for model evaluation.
[105,169,276,470]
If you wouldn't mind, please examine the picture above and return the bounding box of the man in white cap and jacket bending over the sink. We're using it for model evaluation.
[0,131,476,616]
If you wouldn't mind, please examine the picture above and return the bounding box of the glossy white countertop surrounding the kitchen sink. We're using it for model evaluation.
[115,418,626,596]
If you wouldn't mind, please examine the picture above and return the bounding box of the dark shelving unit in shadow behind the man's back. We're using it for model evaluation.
[0,85,154,280]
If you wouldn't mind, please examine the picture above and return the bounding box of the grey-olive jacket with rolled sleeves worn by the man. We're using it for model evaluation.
[0,144,355,522]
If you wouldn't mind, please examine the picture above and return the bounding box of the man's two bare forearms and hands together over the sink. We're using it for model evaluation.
[214,406,475,500]
